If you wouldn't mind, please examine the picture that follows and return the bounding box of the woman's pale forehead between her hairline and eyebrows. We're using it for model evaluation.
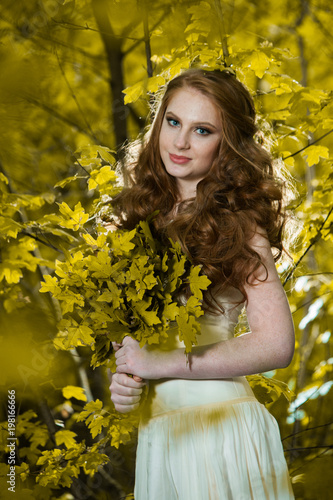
[166,87,220,121]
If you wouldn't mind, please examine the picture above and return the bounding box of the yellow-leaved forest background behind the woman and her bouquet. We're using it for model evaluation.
[0,0,333,500]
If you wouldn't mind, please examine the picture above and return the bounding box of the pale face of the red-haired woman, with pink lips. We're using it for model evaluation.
[159,87,221,200]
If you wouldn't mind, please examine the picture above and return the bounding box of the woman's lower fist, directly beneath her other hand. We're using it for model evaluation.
[108,342,146,413]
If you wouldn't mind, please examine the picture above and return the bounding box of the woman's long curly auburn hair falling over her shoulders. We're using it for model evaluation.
[112,69,286,311]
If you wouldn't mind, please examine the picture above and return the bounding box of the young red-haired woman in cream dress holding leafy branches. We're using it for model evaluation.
[110,69,294,500]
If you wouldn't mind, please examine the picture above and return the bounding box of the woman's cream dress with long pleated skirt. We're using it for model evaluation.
[134,293,294,500]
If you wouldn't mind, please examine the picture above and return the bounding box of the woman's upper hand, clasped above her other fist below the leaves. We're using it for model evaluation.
[115,337,166,379]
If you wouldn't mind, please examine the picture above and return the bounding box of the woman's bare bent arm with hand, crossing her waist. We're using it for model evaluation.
[116,232,294,379]
